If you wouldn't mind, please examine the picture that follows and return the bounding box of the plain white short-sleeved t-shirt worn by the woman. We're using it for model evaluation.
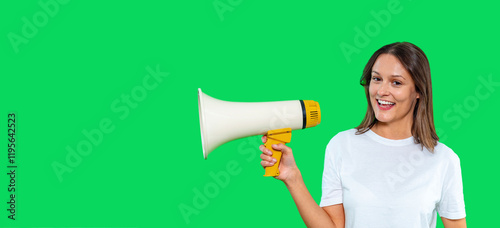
[320,129,465,228]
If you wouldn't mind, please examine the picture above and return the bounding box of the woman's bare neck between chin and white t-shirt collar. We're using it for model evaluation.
[371,121,413,140]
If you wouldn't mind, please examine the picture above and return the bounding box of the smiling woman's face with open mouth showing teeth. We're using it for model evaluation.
[369,54,420,123]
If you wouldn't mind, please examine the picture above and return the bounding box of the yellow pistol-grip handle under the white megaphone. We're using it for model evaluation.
[264,128,292,177]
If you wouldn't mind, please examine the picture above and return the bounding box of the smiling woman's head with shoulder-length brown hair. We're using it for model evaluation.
[356,42,439,151]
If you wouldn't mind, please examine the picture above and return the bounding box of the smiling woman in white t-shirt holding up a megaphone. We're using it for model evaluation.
[260,42,466,228]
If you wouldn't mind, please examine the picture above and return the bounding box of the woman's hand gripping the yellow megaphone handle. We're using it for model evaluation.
[259,135,300,184]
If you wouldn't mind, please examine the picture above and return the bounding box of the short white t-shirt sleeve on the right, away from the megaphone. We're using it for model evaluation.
[437,151,465,219]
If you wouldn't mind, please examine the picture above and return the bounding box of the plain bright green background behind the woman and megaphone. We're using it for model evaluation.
[0,0,500,227]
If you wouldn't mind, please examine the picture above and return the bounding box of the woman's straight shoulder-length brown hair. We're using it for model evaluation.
[356,42,439,152]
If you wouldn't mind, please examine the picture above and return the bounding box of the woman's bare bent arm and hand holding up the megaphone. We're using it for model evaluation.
[260,136,344,228]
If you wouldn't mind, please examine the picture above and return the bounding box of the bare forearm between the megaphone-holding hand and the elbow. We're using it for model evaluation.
[285,173,336,228]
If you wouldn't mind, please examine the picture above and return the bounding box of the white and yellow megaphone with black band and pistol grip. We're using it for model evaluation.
[198,88,321,176]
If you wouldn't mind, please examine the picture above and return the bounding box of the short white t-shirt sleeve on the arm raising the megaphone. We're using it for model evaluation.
[319,135,342,207]
